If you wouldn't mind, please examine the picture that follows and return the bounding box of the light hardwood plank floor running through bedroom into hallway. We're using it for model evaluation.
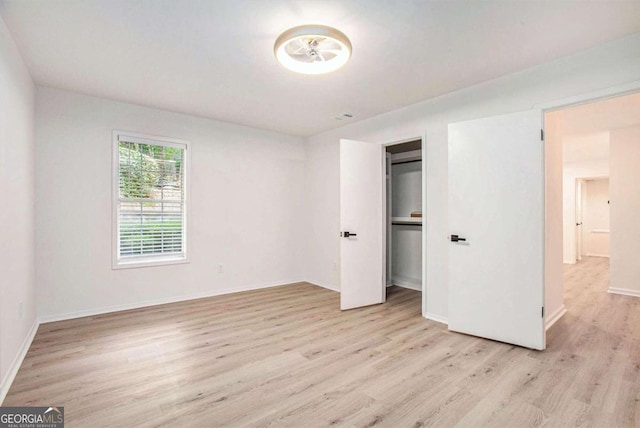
[4,258,640,427]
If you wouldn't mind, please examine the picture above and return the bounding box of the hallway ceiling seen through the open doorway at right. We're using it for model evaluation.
[553,93,640,163]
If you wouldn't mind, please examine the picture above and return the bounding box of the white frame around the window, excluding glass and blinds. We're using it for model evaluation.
[111,130,191,269]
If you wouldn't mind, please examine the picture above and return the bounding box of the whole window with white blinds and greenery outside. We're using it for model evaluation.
[113,131,188,268]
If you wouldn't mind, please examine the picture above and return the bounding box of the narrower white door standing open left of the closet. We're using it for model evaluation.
[340,140,386,309]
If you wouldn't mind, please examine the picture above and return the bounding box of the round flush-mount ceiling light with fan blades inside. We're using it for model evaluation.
[273,25,351,74]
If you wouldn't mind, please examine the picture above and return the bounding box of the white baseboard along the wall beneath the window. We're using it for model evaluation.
[39,280,305,324]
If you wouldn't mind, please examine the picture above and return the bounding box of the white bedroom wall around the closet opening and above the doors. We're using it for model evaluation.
[307,34,640,320]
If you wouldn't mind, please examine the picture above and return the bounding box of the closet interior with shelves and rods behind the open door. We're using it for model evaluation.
[386,140,423,291]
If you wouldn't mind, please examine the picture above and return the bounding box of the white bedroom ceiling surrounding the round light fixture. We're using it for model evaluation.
[0,0,640,136]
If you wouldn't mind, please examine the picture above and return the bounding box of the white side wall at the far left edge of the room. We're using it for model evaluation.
[0,18,36,403]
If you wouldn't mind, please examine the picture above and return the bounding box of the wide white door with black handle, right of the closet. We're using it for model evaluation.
[448,110,545,349]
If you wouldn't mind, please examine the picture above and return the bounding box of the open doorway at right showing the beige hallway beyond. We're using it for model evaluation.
[545,93,640,329]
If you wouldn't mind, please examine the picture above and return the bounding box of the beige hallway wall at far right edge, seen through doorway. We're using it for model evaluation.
[609,126,640,296]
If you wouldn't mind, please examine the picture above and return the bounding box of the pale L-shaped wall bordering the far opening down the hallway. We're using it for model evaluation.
[562,161,609,264]
